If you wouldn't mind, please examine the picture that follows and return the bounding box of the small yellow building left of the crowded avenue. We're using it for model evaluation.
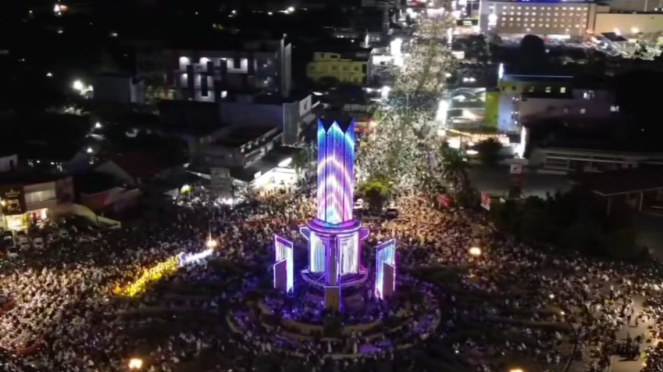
[306,48,372,85]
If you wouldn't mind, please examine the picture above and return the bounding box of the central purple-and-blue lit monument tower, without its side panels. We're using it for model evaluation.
[301,119,368,309]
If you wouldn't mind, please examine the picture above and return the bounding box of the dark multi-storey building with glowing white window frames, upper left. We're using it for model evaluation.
[170,39,292,102]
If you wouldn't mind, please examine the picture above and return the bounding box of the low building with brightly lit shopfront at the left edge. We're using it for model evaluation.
[0,170,74,231]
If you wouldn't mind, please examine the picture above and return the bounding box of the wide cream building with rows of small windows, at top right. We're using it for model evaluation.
[479,0,597,38]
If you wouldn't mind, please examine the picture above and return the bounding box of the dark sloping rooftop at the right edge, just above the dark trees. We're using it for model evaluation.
[569,169,663,196]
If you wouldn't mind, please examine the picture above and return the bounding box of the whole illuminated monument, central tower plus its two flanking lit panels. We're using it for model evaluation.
[274,119,396,309]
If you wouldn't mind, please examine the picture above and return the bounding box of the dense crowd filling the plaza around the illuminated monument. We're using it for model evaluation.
[0,188,663,372]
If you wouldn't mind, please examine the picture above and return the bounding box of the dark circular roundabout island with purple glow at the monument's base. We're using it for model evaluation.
[226,275,440,359]
